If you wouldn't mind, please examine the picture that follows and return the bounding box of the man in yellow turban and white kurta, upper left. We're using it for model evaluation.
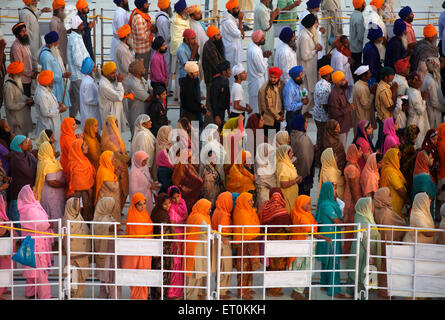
[98,61,127,134]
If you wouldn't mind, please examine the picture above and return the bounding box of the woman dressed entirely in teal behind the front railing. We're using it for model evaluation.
[315,181,345,298]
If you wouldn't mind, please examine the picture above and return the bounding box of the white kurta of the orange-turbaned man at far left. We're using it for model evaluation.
[34,84,62,146]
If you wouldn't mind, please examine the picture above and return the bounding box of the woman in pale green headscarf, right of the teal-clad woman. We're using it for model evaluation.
[346,197,382,298]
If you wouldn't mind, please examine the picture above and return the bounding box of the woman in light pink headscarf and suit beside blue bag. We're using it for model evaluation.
[17,184,53,299]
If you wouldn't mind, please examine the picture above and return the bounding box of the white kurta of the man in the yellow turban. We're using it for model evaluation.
[98,76,127,133]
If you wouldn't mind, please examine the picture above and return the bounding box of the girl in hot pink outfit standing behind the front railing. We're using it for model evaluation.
[168,186,187,299]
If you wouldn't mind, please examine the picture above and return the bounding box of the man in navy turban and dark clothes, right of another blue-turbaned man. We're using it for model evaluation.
[385,19,408,69]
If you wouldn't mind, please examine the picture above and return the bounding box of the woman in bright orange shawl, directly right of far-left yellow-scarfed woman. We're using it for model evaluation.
[68,139,96,221]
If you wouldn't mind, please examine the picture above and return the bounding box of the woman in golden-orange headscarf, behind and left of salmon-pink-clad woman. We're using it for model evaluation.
[101,115,130,208]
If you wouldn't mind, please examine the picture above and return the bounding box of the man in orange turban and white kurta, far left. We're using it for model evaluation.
[34,70,66,147]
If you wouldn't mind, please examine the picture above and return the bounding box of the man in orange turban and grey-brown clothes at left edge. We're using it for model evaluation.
[3,61,34,136]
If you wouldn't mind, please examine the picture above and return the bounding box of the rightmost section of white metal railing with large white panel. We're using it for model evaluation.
[365,225,445,300]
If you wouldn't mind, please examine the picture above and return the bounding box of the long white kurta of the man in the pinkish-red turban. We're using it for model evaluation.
[247,42,268,113]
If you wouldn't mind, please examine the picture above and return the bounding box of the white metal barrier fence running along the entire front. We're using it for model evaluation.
[0,219,445,300]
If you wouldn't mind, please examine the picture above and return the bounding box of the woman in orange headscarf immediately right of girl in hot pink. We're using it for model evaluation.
[184,199,212,300]
